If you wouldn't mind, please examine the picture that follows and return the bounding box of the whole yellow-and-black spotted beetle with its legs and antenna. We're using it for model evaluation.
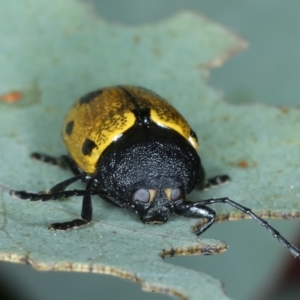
[10,85,300,257]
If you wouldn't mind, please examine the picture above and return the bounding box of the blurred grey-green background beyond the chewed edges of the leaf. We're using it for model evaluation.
[0,0,300,300]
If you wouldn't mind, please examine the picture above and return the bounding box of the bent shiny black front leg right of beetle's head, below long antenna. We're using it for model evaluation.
[174,201,216,235]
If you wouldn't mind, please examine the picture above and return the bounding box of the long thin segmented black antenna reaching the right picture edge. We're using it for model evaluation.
[196,197,300,257]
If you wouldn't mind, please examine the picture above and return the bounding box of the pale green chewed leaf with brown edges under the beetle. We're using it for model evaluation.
[0,0,300,300]
